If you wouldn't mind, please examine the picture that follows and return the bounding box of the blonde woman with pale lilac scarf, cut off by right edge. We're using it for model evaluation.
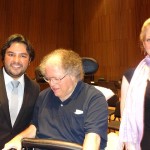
[119,18,150,150]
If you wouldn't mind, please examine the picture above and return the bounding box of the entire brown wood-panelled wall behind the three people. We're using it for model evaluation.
[0,0,150,80]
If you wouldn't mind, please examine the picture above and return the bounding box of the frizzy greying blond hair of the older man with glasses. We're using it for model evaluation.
[39,48,84,80]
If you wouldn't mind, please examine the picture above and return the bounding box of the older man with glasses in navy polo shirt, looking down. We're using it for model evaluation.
[4,49,108,150]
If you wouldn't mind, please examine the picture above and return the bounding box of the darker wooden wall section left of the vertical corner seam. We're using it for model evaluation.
[0,0,74,78]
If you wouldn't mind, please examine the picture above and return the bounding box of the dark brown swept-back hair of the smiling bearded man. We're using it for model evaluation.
[1,34,35,61]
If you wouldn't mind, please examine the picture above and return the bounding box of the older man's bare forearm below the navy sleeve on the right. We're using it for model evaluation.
[83,133,101,150]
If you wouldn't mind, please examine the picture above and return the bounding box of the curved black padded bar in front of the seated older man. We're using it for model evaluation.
[22,138,82,150]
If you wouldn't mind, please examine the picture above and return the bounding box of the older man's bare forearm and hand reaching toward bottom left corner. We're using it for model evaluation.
[3,125,36,150]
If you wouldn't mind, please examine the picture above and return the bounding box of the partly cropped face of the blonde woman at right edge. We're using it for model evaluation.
[143,26,150,55]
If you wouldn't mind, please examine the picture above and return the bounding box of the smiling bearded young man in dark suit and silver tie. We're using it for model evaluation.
[0,34,40,149]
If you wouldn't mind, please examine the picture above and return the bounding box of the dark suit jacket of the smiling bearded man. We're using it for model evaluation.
[0,70,40,150]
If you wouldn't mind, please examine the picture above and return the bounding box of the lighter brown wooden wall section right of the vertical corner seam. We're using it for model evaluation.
[74,0,150,80]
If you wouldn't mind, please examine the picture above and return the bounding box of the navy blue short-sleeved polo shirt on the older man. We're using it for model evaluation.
[32,81,108,149]
